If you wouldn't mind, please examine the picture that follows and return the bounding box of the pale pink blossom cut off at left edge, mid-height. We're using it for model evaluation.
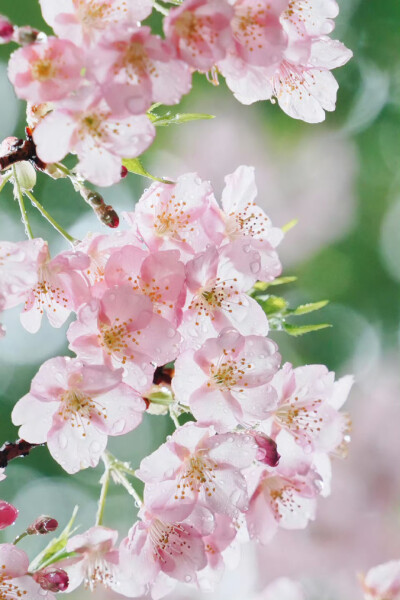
[0,238,47,310]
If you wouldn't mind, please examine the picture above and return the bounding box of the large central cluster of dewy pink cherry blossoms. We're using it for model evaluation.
[0,166,352,598]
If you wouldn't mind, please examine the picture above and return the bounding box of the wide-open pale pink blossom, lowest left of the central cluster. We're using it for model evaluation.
[12,357,145,473]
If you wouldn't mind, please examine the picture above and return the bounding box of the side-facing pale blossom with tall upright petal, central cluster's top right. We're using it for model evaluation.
[222,165,283,281]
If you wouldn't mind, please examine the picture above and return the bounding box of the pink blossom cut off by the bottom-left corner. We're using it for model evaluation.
[0,544,55,600]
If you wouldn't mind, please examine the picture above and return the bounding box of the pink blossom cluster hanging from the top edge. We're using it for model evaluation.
[0,0,352,186]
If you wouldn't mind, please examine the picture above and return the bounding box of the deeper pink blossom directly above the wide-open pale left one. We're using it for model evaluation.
[67,285,180,392]
